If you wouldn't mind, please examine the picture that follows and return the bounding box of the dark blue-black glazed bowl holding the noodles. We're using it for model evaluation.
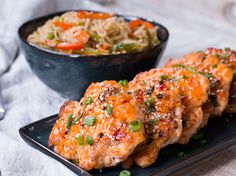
[18,11,169,99]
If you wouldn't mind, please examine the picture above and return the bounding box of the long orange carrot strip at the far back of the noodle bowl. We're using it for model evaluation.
[77,11,115,19]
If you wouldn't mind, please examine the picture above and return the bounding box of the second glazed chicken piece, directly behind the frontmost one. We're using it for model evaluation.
[128,69,183,167]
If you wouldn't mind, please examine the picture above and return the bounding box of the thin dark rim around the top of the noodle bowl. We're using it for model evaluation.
[18,9,169,60]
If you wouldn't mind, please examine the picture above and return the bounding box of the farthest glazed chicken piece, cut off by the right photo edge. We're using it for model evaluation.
[205,48,236,113]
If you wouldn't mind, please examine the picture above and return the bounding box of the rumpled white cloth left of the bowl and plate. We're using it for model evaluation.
[0,0,108,176]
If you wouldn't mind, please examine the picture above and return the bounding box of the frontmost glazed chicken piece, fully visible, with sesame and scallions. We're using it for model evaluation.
[49,81,145,170]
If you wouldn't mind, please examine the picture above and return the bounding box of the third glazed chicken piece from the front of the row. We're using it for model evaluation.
[159,67,209,144]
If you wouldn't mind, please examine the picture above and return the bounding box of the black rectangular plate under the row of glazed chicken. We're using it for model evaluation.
[19,114,236,176]
